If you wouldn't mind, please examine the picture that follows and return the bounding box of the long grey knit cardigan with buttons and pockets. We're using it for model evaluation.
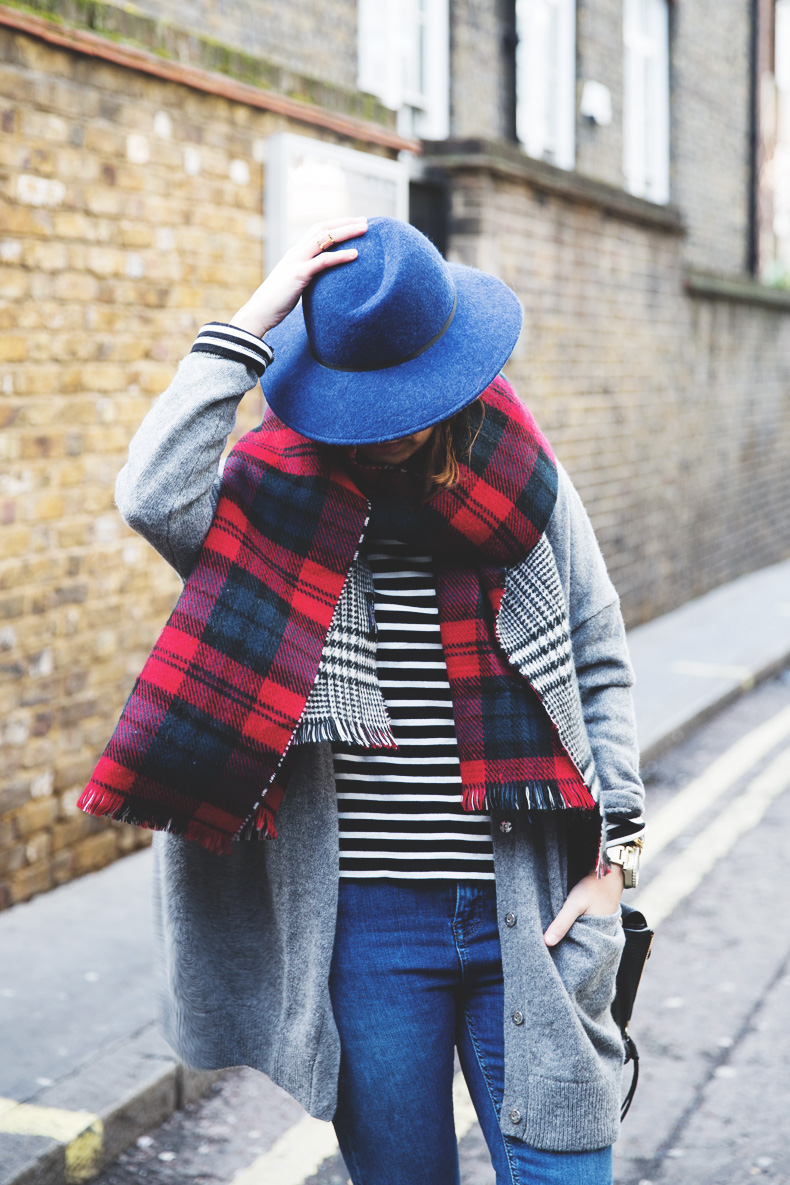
[116,353,643,1151]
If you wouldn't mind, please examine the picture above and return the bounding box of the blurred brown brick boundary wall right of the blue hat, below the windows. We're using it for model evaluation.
[449,165,790,624]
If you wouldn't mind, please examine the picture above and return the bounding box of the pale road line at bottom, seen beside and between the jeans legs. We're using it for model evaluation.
[232,1074,477,1185]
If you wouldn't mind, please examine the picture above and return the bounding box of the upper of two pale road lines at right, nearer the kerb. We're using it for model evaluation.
[642,707,790,864]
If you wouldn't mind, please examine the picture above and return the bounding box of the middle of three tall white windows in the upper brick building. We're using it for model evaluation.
[515,0,576,168]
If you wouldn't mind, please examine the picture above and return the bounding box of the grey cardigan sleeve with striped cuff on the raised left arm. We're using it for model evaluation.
[115,322,272,578]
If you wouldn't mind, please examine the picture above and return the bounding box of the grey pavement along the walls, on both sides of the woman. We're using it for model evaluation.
[0,561,790,1185]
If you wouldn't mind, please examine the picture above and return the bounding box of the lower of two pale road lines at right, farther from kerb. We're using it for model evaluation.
[634,748,790,927]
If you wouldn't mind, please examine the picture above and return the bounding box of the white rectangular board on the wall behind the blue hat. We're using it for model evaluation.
[265,133,409,271]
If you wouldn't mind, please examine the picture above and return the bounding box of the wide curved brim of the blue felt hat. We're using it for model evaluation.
[261,263,521,444]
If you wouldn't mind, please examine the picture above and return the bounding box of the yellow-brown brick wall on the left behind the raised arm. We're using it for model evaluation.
[0,28,397,907]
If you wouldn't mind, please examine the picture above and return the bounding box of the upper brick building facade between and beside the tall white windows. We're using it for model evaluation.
[451,0,751,273]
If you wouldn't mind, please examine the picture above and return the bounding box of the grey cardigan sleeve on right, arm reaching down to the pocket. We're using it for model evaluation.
[546,466,644,847]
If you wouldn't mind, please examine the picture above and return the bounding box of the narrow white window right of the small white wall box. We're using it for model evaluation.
[623,0,669,203]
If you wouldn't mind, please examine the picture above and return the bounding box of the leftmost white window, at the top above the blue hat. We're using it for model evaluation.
[358,0,450,140]
